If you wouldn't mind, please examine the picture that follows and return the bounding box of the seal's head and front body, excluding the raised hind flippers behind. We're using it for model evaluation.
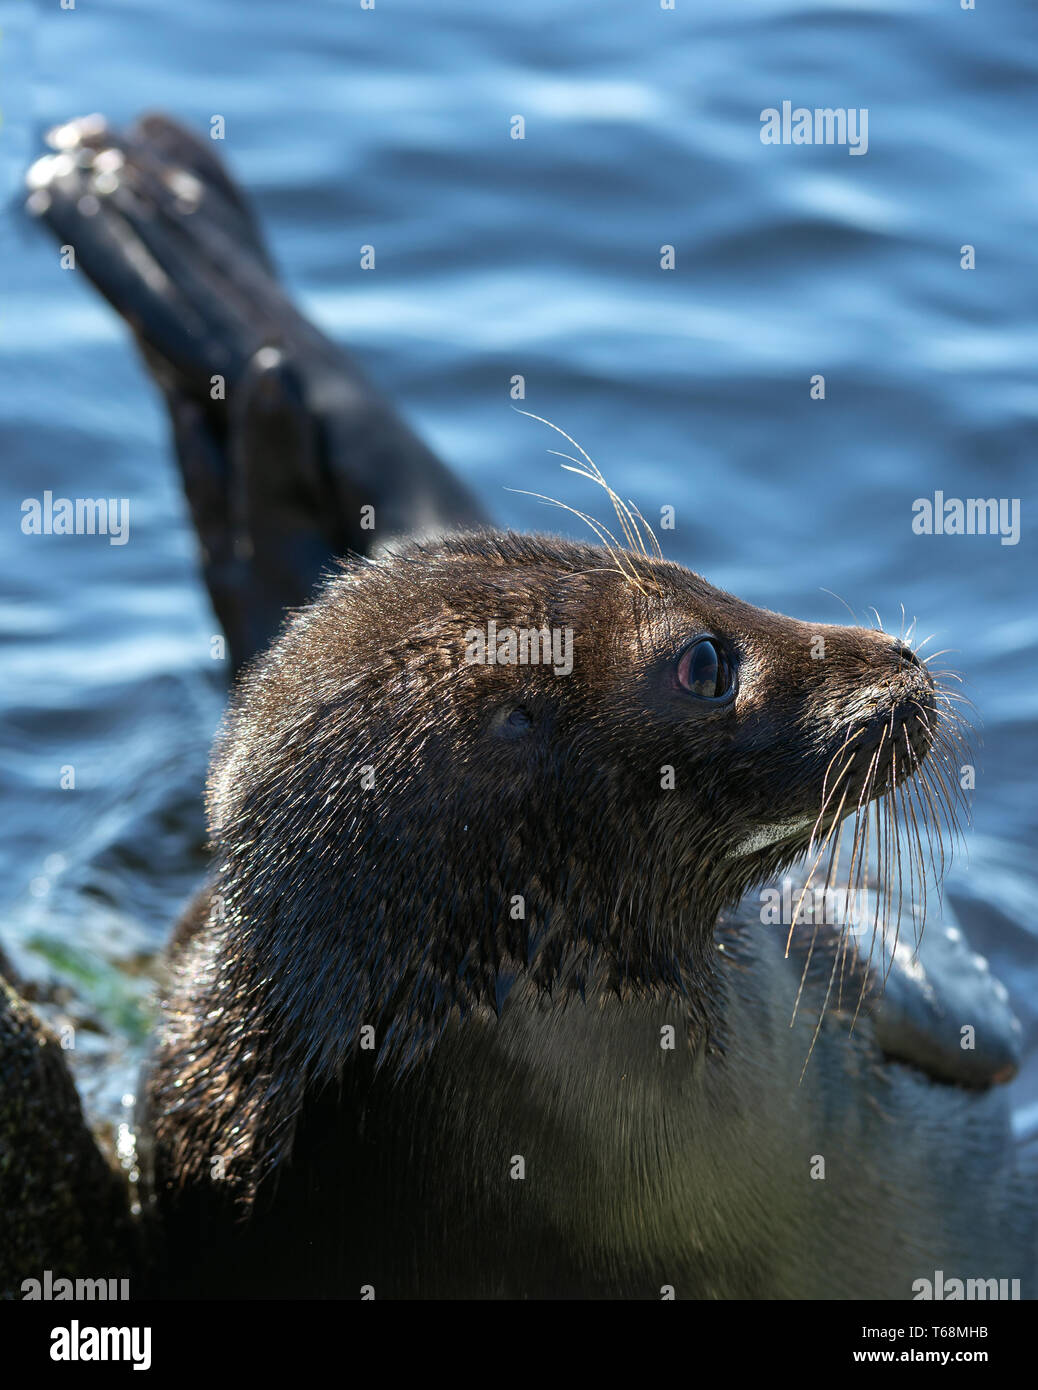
[142,531,1034,1298]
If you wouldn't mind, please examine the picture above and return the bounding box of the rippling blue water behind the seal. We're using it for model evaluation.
[0,0,1038,1119]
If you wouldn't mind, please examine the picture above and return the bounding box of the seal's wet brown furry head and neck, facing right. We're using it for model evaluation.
[153,532,956,1194]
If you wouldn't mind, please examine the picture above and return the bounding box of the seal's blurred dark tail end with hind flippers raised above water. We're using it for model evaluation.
[28,115,486,669]
